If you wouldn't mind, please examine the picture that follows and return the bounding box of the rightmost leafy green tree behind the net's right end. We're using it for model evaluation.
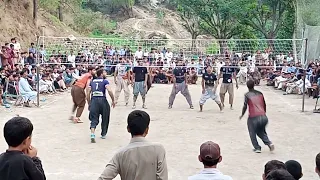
[238,0,294,47]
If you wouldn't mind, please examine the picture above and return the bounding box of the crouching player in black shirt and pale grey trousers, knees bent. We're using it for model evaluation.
[199,65,223,112]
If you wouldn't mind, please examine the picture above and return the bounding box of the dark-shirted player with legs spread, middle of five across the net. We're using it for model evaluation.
[169,60,193,109]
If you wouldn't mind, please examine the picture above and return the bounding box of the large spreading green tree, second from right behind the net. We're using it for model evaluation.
[179,0,243,53]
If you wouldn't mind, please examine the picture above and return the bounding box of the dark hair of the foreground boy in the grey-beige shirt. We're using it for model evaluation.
[127,110,150,136]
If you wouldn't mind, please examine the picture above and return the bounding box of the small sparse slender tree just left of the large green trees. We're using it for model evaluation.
[178,5,202,50]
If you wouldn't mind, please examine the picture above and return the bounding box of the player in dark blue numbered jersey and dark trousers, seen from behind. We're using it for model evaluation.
[88,69,115,143]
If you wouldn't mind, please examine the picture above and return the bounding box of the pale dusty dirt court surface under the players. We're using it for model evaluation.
[0,80,320,180]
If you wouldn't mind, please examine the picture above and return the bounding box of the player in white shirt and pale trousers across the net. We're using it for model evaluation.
[114,59,131,106]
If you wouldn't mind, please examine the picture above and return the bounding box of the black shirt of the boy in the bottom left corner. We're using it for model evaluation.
[0,151,46,180]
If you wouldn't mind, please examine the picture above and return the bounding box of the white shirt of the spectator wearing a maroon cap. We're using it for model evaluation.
[188,168,232,180]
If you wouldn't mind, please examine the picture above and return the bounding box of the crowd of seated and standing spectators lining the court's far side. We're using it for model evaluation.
[0,38,320,106]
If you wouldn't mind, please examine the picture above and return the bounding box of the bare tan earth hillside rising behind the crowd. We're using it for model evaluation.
[0,0,190,47]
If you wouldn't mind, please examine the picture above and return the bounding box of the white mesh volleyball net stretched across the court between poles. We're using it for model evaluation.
[38,36,307,66]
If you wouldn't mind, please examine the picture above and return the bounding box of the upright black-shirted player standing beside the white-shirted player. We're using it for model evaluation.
[132,60,149,109]
